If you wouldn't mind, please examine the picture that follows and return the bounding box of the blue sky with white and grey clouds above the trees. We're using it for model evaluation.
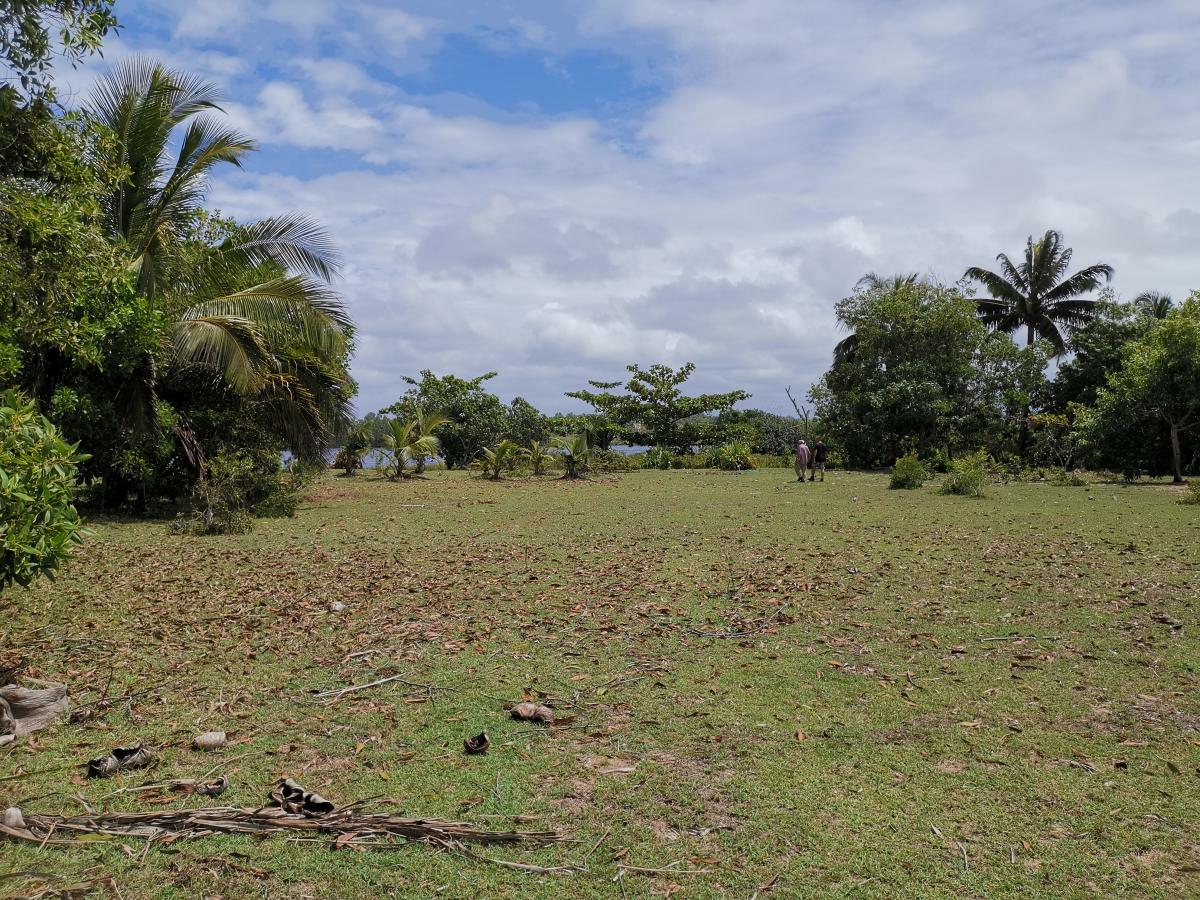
[60,0,1200,413]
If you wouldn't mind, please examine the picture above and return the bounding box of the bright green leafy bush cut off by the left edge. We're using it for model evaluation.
[0,394,86,590]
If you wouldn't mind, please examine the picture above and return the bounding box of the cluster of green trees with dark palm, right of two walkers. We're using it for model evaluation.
[811,230,1200,481]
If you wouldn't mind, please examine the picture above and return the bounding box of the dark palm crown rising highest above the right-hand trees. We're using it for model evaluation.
[965,230,1112,356]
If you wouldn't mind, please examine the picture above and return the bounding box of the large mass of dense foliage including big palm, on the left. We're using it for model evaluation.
[0,54,354,528]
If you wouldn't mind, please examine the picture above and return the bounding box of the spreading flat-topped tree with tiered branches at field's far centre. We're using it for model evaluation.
[566,362,750,452]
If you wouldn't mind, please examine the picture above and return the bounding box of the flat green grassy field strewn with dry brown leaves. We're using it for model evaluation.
[0,470,1200,898]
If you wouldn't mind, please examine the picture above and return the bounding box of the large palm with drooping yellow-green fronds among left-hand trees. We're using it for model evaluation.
[86,58,353,458]
